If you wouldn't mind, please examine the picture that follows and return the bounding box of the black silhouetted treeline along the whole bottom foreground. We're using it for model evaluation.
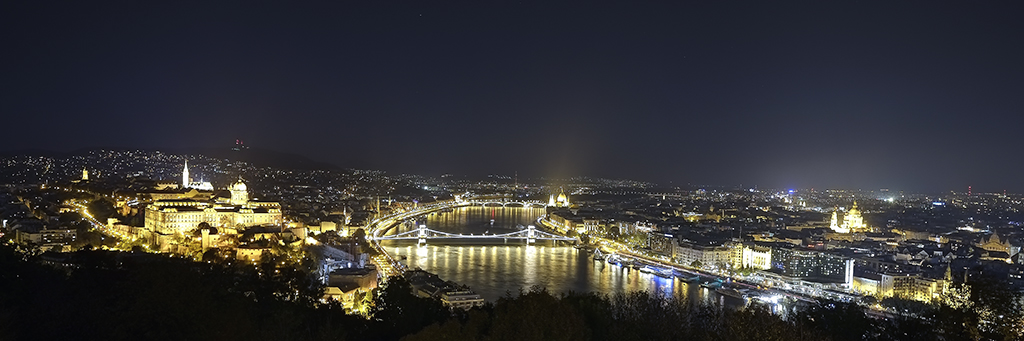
[0,246,1020,341]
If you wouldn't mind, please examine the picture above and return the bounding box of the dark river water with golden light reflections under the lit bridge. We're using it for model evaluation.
[384,207,736,305]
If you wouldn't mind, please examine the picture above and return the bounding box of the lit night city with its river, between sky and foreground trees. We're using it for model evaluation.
[0,142,1024,340]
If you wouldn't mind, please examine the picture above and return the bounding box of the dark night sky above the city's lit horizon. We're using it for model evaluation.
[0,1,1024,191]
